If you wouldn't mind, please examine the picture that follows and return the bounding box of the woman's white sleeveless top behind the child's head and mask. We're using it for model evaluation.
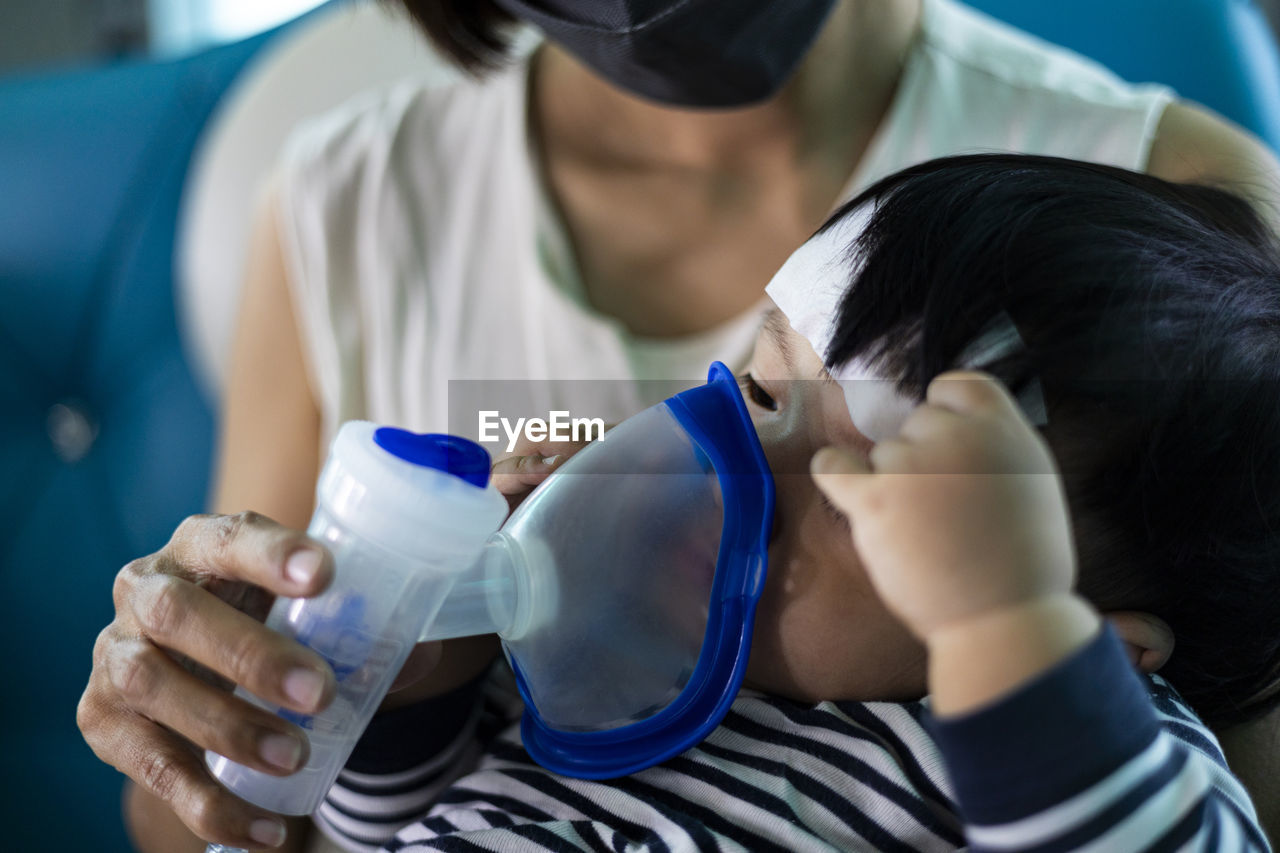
[276,0,1172,441]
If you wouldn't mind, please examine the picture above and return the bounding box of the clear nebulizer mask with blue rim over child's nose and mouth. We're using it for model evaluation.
[422,362,773,777]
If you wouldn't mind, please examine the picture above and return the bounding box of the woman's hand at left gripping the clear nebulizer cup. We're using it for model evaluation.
[77,512,334,847]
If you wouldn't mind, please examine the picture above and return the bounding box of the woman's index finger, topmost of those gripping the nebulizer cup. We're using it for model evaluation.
[157,512,333,598]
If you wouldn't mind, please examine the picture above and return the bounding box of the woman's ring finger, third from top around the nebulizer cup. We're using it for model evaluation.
[108,630,308,776]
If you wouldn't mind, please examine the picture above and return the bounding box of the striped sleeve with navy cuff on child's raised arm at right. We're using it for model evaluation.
[931,629,1270,852]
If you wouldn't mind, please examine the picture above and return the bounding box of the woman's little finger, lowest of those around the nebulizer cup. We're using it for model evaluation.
[90,710,294,848]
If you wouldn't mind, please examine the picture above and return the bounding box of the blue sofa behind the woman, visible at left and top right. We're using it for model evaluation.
[0,0,1280,853]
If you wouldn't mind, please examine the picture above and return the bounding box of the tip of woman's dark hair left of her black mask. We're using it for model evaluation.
[391,0,515,74]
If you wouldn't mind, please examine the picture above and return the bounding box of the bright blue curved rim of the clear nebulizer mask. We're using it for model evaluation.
[508,361,774,779]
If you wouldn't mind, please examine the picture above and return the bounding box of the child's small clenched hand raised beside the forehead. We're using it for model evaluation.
[813,371,1097,693]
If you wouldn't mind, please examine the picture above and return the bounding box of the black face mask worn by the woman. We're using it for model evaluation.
[497,0,836,108]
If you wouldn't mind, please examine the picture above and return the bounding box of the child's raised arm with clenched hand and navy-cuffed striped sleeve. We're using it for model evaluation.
[813,374,1266,849]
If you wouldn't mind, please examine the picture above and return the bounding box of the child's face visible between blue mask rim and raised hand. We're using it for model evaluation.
[741,311,925,701]
